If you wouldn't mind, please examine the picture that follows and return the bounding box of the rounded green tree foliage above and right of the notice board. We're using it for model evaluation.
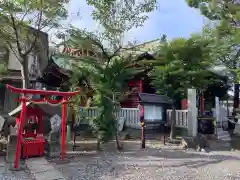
[151,34,220,101]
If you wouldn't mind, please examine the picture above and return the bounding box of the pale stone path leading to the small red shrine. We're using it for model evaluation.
[26,158,65,180]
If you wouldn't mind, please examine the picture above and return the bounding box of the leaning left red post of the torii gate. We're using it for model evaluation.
[14,97,27,169]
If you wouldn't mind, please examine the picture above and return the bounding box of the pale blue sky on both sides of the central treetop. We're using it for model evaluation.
[65,0,206,43]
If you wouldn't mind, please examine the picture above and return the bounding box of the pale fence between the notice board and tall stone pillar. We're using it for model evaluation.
[167,109,188,128]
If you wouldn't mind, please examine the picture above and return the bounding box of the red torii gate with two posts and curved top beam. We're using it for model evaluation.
[6,84,80,169]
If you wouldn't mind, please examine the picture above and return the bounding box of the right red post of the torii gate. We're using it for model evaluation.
[61,96,67,160]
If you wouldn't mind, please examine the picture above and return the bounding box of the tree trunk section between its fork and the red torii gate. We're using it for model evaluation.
[20,56,30,89]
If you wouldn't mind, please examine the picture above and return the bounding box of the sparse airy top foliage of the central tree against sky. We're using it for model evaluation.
[87,0,157,51]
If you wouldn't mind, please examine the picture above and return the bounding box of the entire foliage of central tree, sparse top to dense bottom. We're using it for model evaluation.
[57,0,156,143]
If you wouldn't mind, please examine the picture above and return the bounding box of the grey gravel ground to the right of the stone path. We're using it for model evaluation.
[51,141,240,180]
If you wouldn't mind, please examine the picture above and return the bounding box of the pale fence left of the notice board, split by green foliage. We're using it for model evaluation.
[78,107,140,129]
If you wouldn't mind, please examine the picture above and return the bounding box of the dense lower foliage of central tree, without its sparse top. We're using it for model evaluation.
[60,29,142,142]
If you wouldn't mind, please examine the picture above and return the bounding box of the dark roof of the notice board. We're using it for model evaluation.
[139,93,172,104]
